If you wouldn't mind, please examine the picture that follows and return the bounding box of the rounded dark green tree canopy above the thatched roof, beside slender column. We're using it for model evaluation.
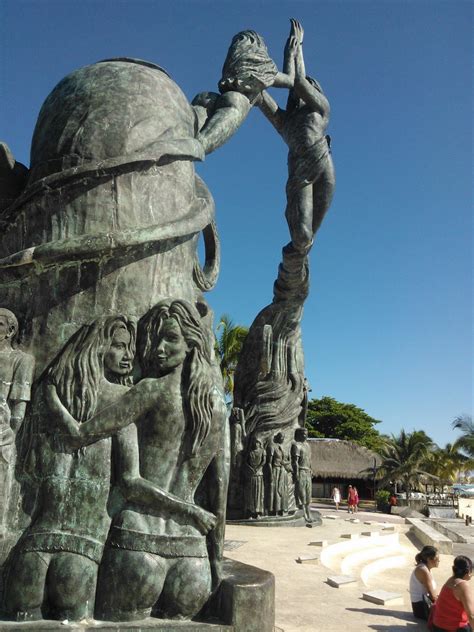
[306,396,382,450]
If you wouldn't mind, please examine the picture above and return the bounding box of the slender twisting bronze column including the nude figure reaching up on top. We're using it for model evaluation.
[229,20,335,521]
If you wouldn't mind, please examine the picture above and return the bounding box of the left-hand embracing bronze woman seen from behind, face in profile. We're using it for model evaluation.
[5,316,135,620]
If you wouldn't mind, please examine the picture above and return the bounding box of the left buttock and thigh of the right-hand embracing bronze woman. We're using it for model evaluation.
[95,547,167,621]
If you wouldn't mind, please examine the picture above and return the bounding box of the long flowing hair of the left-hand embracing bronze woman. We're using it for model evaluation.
[48,316,136,421]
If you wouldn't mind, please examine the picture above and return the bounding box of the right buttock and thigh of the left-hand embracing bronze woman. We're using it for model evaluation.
[46,552,98,621]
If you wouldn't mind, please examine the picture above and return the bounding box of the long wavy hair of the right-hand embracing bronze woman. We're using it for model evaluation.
[137,299,214,456]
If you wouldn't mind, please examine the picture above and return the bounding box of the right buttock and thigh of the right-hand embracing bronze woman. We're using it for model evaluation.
[156,557,211,619]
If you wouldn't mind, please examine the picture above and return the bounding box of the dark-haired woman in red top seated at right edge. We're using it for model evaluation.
[432,555,474,632]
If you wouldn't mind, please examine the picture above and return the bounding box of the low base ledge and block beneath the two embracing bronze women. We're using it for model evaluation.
[0,559,275,632]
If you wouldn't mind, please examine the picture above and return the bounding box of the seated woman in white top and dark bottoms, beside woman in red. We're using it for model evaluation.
[410,546,439,621]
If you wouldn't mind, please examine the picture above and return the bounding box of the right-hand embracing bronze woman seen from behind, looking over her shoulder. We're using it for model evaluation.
[96,300,227,621]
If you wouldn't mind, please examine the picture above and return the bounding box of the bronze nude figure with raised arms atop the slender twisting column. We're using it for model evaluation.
[258,20,335,253]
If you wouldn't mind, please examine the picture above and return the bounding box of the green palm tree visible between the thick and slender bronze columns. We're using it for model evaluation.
[216,314,249,398]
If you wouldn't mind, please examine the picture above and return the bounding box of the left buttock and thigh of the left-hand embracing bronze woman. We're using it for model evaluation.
[5,551,51,621]
